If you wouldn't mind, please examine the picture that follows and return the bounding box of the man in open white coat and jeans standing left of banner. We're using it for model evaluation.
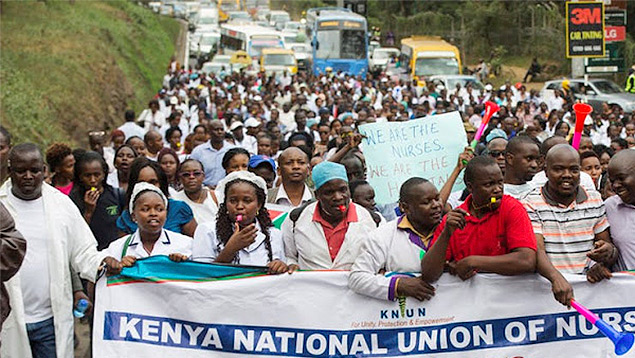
[0,144,109,358]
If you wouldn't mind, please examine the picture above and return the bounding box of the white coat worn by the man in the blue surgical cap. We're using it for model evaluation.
[282,202,376,270]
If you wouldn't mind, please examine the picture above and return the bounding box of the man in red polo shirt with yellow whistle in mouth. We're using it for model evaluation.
[421,156,536,282]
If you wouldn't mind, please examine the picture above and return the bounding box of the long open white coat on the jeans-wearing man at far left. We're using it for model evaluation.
[0,180,105,358]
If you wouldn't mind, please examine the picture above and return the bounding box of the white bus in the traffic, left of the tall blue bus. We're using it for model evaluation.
[220,24,284,60]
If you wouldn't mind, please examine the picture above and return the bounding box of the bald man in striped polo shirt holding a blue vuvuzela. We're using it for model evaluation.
[524,144,617,306]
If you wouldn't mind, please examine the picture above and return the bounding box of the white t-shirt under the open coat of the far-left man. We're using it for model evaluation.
[9,193,53,323]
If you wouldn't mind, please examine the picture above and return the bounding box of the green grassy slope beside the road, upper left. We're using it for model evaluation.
[0,1,180,146]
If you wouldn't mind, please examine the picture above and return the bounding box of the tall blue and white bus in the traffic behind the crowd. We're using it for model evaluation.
[307,7,368,78]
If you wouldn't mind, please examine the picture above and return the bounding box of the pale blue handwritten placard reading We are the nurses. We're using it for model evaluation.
[359,112,467,204]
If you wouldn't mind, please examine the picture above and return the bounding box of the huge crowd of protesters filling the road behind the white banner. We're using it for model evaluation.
[0,56,635,357]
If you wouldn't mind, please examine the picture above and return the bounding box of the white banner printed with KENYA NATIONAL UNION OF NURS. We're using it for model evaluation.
[93,262,635,358]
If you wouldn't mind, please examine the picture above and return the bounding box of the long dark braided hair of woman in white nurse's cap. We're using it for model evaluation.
[216,179,273,264]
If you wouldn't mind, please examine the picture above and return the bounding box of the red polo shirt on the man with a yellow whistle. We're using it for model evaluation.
[433,195,536,261]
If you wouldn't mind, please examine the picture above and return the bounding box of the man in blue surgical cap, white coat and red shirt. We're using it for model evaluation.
[282,162,375,270]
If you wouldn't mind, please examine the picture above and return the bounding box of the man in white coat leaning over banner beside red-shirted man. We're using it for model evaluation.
[348,177,443,301]
